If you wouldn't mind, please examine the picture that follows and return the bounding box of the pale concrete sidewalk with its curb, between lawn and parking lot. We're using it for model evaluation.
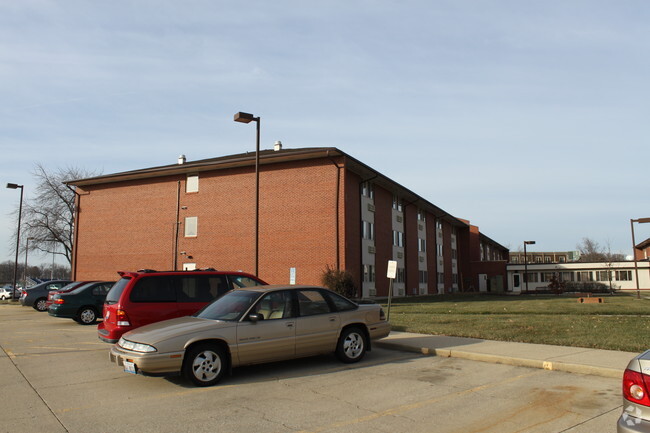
[373,331,637,378]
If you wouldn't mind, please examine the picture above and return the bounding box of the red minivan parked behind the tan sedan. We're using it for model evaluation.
[97,270,266,343]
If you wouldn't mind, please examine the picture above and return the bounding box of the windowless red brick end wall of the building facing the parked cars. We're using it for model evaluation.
[76,159,345,284]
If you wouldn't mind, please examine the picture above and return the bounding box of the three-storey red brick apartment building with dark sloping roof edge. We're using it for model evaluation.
[68,148,508,297]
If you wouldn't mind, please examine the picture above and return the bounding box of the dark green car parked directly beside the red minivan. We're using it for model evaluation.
[47,281,115,325]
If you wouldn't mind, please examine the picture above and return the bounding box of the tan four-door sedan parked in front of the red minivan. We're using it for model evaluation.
[110,286,390,386]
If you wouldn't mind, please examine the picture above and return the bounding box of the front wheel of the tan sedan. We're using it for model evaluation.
[183,343,228,386]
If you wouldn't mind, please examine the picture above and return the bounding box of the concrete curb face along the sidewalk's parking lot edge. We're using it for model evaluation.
[373,340,623,379]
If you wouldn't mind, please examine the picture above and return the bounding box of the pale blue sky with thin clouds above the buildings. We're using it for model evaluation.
[0,0,650,260]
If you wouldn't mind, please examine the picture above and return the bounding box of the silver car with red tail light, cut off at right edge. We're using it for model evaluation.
[616,350,650,433]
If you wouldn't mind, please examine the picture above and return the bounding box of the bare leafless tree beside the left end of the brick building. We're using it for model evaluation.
[21,163,95,264]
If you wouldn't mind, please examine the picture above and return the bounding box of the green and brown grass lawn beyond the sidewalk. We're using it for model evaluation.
[384,295,650,352]
